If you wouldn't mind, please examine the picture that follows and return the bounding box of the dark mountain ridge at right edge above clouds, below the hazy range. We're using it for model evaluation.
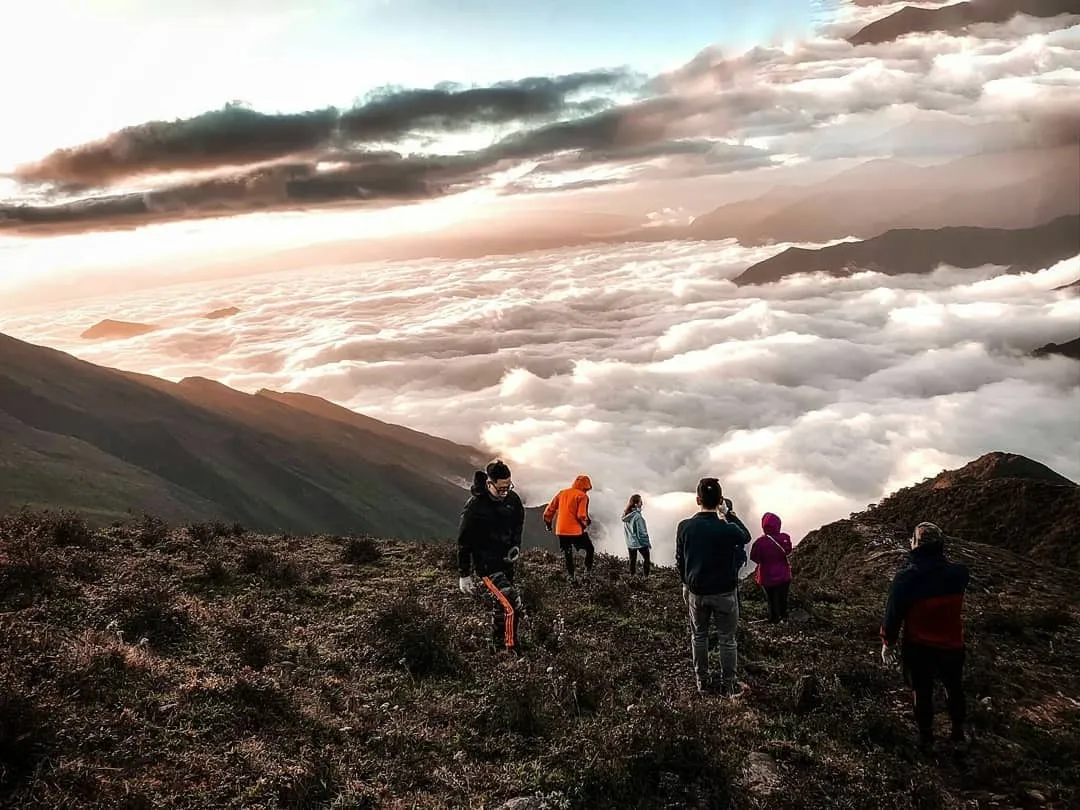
[734,216,1080,285]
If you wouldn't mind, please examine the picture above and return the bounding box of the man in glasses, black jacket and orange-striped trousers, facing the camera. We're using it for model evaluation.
[458,460,525,651]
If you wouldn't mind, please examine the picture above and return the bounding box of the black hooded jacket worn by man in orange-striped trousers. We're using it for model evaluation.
[458,473,525,577]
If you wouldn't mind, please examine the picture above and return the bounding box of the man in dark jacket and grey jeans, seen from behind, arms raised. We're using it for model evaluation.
[675,477,750,698]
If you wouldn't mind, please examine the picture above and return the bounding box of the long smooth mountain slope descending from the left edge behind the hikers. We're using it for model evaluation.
[0,336,483,538]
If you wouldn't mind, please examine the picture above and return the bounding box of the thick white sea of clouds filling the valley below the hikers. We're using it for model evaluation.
[0,242,1080,562]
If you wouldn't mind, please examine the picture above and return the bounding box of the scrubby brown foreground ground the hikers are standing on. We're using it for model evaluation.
[6,451,1080,810]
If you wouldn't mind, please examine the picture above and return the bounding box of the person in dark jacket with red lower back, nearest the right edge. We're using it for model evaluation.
[881,523,970,751]
